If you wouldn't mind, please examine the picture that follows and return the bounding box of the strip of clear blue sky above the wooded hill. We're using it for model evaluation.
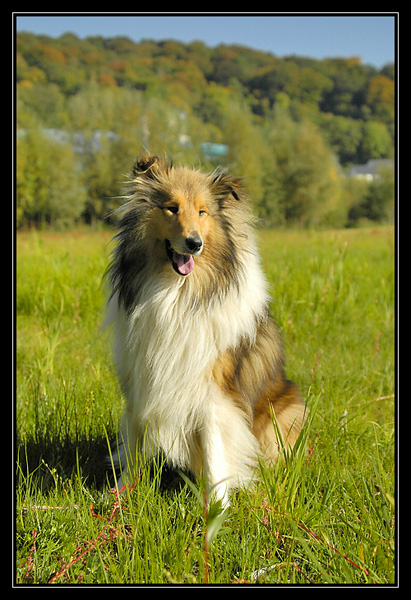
[14,13,397,68]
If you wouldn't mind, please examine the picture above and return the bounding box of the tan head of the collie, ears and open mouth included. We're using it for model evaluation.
[130,157,243,277]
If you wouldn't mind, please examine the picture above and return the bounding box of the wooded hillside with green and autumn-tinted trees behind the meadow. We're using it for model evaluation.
[15,33,395,229]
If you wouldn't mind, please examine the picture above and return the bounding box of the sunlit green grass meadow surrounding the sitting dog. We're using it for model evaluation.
[15,228,396,584]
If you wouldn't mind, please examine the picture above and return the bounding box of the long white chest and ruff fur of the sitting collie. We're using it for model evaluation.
[109,248,268,474]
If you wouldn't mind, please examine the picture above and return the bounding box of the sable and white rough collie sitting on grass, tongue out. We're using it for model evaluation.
[108,156,305,501]
